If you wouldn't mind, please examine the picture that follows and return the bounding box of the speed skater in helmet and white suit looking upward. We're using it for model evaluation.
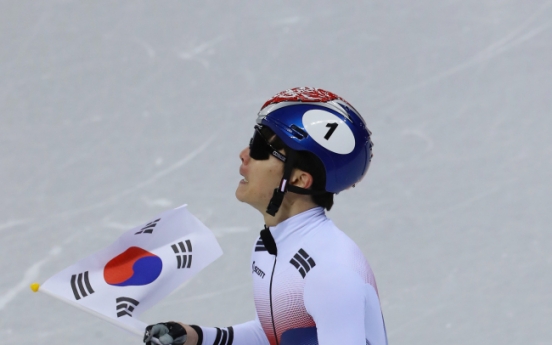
[144,87,387,345]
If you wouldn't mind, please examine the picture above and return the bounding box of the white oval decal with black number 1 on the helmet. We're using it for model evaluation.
[303,109,355,155]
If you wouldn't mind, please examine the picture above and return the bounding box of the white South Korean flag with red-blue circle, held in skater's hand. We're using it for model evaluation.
[40,205,222,334]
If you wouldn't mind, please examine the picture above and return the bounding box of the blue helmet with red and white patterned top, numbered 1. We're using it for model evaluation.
[257,87,373,193]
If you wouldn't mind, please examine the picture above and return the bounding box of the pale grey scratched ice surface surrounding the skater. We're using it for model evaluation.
[0,0,552,345]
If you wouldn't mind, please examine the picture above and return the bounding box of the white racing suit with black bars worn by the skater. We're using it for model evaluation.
[194,207,387,345]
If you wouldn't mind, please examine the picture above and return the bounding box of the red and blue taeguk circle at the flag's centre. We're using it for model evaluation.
[104,247,163,286]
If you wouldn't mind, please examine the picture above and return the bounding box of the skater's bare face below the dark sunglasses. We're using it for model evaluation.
[236,134,284,213]
